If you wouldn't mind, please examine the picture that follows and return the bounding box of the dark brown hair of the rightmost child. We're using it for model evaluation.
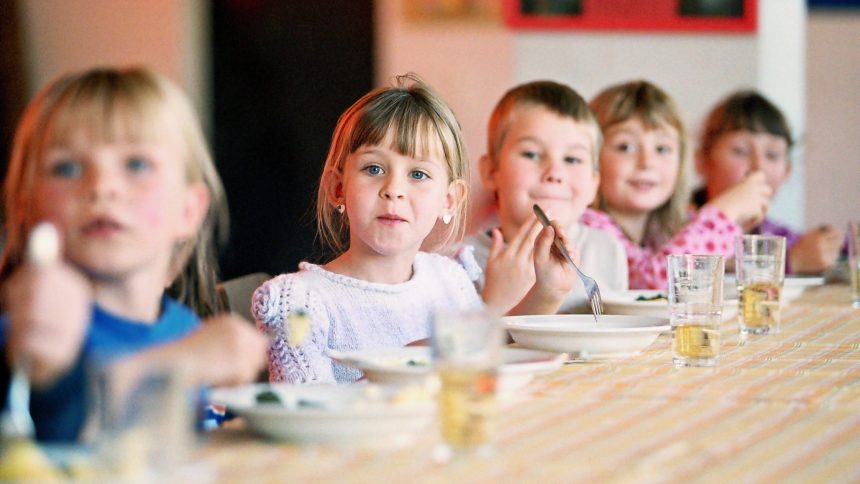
[699,90,794,161]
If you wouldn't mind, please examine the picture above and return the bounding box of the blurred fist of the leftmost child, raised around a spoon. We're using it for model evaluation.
[3,222,93,387]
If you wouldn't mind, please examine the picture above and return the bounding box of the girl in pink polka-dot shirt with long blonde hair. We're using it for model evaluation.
[582,81,772,289]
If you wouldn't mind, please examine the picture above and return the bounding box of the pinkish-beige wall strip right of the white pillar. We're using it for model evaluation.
[802,11,860,228]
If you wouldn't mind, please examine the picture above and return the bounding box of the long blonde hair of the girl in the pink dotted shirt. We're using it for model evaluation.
[591,80,690,244]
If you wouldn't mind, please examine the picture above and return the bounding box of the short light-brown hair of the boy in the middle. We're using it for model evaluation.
[487,81,603,170]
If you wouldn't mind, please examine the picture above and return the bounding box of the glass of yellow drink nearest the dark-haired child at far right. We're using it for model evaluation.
[735,235,785,334]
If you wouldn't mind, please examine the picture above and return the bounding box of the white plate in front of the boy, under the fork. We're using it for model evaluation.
[504,314,670,360]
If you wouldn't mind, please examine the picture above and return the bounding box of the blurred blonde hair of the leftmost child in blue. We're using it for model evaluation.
[0,67,228,317]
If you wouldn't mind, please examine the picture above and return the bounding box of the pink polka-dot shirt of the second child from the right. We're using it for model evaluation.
[580,205,743,289]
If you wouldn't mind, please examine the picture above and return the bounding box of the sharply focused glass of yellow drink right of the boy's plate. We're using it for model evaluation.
[667,254,725,367]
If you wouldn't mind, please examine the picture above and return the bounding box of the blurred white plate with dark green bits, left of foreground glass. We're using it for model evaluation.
[209,383,436,447]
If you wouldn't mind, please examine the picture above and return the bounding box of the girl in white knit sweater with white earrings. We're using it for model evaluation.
[252,75,574,383]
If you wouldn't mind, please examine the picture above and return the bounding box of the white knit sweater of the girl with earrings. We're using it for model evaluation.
[251,252,483,383]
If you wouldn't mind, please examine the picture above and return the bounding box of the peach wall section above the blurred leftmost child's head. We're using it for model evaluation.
[18,0,210,127]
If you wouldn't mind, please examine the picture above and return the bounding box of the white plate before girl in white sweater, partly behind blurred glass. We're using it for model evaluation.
[329,346,567,397]
